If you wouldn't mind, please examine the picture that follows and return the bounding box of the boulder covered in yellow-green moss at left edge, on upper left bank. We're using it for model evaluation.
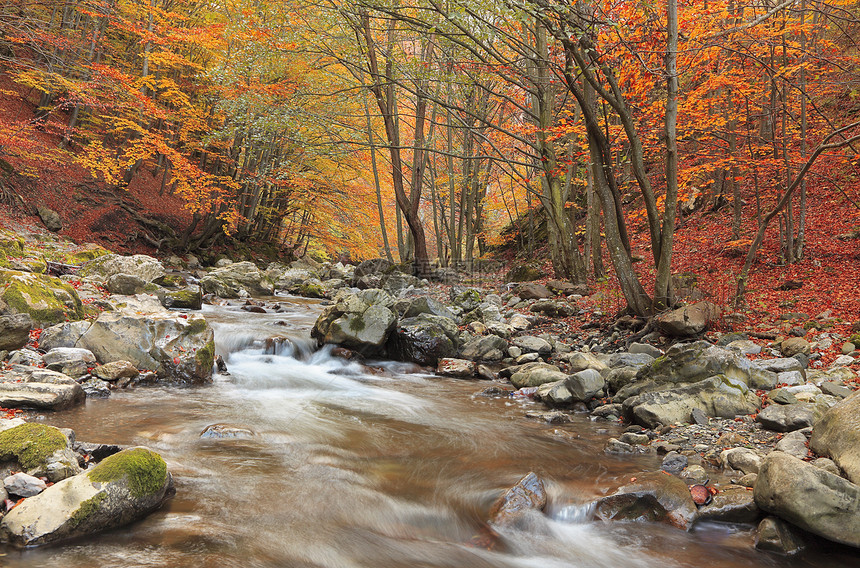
[0,269,84,327]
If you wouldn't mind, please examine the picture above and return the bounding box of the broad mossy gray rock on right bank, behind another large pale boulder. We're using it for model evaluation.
[637,341,752,385]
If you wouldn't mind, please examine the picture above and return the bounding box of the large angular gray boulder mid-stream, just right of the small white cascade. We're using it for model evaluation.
[311,289,397,354]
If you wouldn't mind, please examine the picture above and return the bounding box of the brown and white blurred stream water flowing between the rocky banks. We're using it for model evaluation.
[0,298,857,568]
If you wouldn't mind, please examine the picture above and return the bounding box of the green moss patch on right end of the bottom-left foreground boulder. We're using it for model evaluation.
[87,448,167,497]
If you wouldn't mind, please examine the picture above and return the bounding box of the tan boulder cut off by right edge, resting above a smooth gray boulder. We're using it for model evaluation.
[810,391,860,485]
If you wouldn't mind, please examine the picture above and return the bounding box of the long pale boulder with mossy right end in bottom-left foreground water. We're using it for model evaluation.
[0,447,173,547]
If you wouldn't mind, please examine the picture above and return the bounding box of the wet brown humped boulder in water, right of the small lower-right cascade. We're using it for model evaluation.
[594,471,696,530]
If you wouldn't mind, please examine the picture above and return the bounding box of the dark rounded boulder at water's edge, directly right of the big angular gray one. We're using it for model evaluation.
[386,313,460,366]
